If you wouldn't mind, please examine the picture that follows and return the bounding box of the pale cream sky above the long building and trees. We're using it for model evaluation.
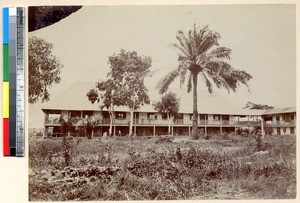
[29,4,296,127]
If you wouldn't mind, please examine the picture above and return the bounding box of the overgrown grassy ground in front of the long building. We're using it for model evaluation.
[29,132,296,201]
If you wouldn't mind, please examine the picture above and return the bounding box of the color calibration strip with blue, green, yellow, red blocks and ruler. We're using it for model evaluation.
[3,7,25,156]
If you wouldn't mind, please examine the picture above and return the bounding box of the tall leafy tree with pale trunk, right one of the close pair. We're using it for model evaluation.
[108,49,151,135]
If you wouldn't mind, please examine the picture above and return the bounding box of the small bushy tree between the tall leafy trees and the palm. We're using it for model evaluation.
[153,92,180,134]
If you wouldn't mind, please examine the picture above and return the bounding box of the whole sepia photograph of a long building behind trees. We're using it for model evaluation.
[28,4,297,201]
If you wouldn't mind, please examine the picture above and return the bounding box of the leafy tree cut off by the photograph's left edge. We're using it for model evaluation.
[28,37,63,103]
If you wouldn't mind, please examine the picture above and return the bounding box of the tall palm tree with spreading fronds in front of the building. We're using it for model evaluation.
[157,24,252,137]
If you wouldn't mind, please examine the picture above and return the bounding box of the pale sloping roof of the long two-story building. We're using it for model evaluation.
[42,82,264,115]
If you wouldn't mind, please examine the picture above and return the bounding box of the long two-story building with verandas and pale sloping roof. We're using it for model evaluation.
[42,82,295,137]
